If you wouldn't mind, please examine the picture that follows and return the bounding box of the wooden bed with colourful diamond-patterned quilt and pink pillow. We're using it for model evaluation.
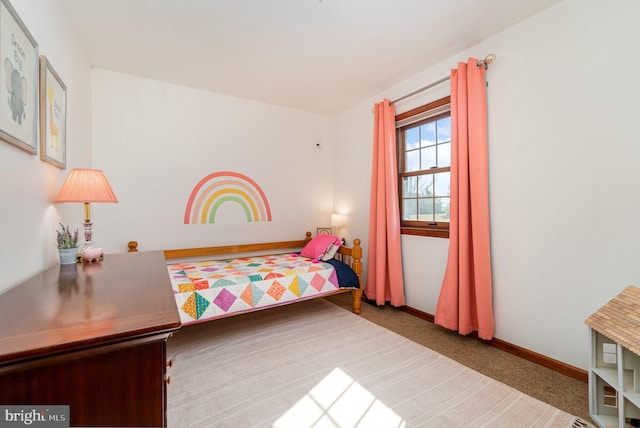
[128,232,362,325]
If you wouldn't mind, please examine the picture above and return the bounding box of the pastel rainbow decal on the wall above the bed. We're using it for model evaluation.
[184,171,271,224]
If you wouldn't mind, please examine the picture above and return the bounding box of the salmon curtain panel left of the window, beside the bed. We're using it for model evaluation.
[365,99,404,306]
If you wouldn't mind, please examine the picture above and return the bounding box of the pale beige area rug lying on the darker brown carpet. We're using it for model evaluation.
[168,299,589,428]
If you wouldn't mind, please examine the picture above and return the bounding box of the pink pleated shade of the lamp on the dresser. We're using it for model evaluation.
[54,168,118,203]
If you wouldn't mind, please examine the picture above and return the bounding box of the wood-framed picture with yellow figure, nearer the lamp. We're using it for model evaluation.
[40,55,67,169]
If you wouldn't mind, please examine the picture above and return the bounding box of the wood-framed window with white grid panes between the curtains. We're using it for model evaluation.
[396,97,451,237]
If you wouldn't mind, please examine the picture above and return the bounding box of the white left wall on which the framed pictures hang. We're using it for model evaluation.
[0,0,91,292]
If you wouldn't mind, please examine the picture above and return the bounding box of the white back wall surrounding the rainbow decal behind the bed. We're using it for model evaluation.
[92,69,333,252]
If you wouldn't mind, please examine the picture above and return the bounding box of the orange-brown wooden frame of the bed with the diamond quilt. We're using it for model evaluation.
[127,232,362,314]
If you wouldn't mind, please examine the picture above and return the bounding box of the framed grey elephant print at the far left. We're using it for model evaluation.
[0,0,39,154]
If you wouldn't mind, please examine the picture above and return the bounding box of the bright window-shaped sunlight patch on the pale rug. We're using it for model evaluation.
[273,367,406,428]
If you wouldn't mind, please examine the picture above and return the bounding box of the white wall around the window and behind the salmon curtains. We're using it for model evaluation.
[334,0,640,368]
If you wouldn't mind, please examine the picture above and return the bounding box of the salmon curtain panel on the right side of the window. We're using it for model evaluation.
[435,58,494,340]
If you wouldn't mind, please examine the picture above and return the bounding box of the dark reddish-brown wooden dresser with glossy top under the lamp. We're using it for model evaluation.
[0,251,180,427]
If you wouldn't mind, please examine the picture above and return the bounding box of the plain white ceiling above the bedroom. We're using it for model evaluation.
[63,0,560,116]
